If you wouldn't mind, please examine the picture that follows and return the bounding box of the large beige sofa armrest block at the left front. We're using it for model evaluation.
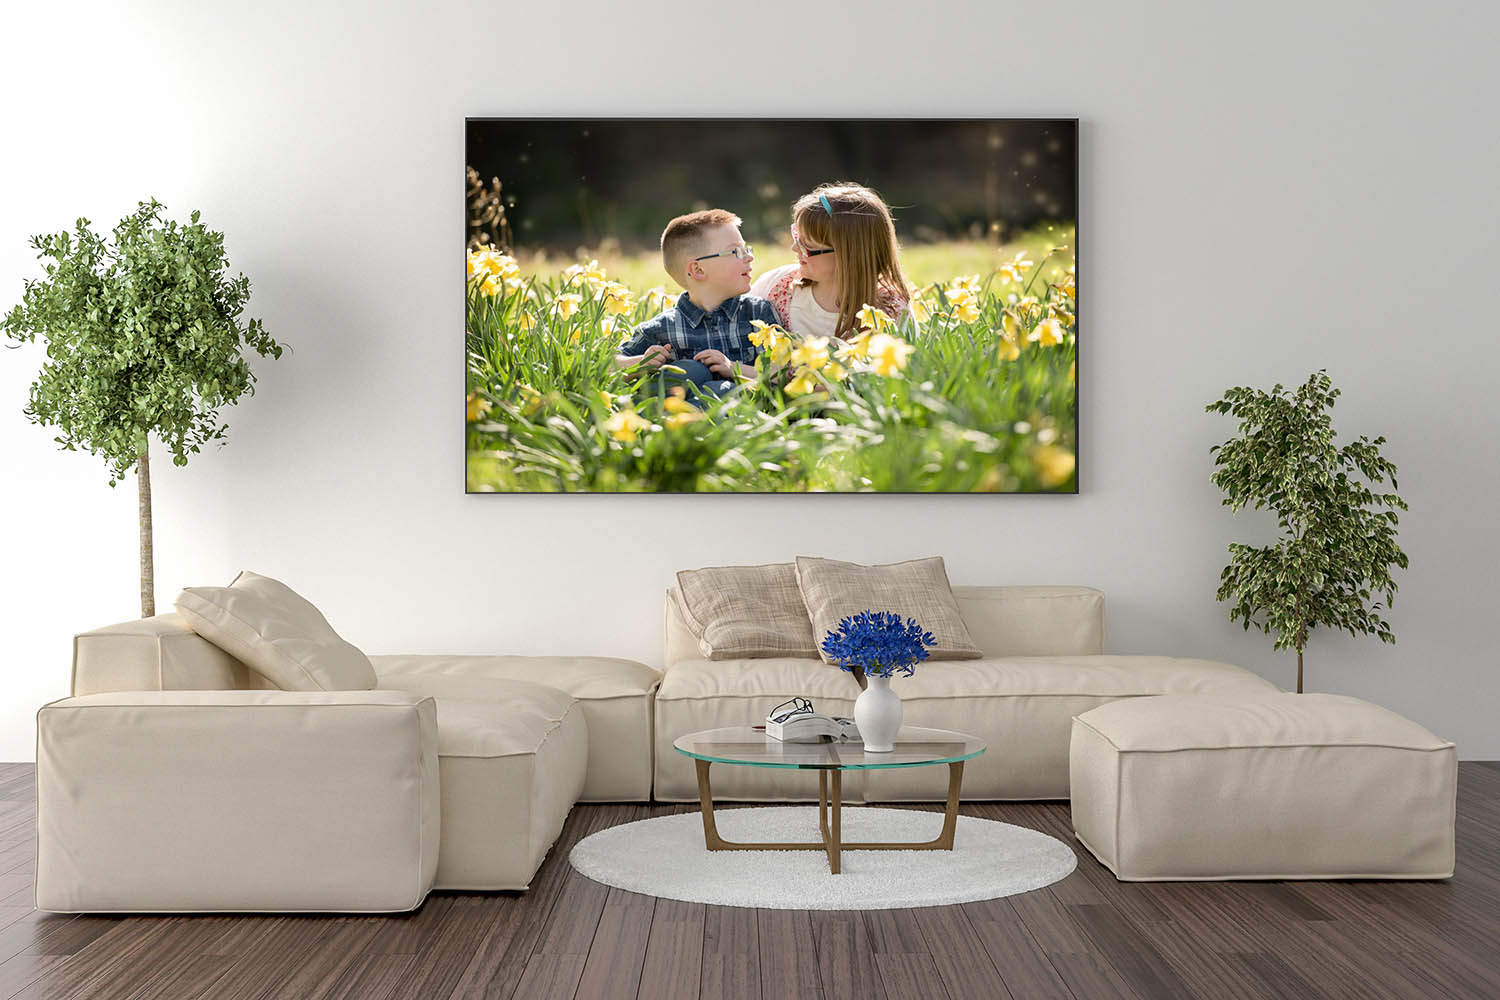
[36,691,440,913]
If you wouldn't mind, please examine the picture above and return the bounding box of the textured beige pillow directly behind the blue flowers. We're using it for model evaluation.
[797,556,984,661]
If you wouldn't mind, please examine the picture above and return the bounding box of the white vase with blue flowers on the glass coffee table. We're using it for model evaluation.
[822,610,938,754]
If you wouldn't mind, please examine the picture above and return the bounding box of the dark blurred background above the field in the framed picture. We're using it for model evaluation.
[467,118,1077,258]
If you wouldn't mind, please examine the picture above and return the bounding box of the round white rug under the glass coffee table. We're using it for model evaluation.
[569,805,1077,910]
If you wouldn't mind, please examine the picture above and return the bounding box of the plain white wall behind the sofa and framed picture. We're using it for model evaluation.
[0,0,1500,760]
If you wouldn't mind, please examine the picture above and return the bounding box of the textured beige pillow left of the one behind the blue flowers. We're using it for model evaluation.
[677,562,818,660]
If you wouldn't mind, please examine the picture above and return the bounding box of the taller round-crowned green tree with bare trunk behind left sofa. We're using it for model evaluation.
[0,199,282,616]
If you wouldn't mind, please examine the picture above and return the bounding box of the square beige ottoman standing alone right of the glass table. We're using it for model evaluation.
[1070,694,1458,882]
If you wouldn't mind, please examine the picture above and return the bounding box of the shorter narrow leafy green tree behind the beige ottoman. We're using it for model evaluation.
[1208,370,1407,693]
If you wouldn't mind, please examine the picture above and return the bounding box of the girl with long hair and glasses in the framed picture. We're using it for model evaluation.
[750,181,908,340]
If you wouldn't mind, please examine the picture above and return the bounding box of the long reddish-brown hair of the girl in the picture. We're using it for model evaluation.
[792,181,908,339]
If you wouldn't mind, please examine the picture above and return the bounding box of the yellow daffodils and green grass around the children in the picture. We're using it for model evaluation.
[467,247,1077,492]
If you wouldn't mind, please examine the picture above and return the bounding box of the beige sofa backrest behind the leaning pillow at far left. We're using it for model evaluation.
[72,615,273,696]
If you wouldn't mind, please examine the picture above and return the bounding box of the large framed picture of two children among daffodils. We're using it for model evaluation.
[465,118,1079,493]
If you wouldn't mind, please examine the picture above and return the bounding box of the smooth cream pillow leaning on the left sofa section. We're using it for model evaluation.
[177,573,375,691]
